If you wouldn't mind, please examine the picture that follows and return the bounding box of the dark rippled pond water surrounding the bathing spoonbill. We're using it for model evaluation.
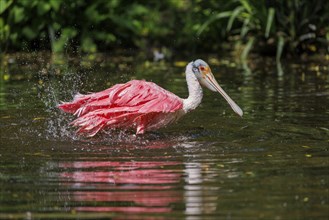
[0,54,329,219]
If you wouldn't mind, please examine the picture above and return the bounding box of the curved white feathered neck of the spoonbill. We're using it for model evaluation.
[183,63,203,113]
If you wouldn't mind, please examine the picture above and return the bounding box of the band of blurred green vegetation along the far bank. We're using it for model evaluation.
[0,0,329,59]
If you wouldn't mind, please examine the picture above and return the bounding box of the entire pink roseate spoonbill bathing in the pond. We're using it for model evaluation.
[58,59,243,137]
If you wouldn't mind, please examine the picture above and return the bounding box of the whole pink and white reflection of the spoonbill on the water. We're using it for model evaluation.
[55,138,218,215]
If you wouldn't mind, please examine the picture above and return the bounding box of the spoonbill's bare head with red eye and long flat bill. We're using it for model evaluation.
[191,59,243,116]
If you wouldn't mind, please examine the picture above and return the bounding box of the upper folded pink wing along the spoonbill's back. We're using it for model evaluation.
[58,80,183,116]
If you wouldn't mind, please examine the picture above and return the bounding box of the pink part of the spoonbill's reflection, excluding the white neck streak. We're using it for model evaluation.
[59,139,184,213]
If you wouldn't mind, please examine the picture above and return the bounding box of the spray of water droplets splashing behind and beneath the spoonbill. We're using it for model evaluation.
[34,55,199,144]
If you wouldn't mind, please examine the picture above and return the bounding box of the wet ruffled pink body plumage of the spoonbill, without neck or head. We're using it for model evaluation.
[58,80,183,136]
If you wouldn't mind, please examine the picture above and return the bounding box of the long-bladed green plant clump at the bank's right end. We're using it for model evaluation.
[198,0,329,61]
